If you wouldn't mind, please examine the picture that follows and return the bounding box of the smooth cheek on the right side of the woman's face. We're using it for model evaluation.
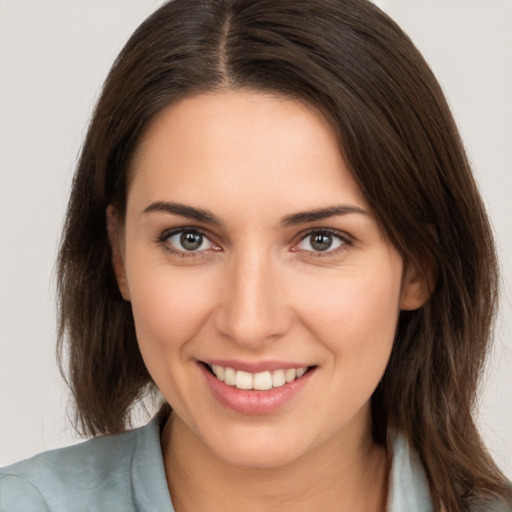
[303,266,400,425]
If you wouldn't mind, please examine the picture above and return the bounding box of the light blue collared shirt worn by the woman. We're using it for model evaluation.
[0,417,433,512]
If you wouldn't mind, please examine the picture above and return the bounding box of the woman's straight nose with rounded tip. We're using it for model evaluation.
[215,251,292,350]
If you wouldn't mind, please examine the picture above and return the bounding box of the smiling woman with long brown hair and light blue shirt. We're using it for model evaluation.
[0,0,512,512]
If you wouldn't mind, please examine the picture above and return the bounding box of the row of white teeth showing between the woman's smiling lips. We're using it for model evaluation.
[205,363,313,391]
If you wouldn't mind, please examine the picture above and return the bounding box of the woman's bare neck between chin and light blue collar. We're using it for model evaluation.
[162,414,388,512]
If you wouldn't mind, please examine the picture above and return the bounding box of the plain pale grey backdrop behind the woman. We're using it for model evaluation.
[0,0,512,478]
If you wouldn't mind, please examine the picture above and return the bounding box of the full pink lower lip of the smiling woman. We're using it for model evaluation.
[199,363,315,416]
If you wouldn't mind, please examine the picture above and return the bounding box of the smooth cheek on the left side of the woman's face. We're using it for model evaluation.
[129,260,220,410]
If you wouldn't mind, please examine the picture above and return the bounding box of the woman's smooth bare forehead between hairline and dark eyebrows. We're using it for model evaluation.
[129,91,367,215]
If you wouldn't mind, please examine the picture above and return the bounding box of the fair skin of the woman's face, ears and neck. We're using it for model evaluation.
[108,91,427,512]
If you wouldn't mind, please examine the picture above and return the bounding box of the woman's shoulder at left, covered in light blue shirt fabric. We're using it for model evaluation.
[0,420,173,512]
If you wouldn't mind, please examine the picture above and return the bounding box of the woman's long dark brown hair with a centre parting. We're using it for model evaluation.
[58,0,512,512]
